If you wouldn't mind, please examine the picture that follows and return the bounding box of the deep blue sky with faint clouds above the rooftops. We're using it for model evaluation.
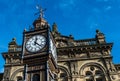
[0,0,120,72]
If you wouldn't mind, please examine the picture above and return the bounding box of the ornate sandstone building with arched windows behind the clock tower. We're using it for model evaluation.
[2,15,120,81]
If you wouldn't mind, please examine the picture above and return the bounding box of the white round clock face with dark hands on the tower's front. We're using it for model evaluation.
[25,35,46,52]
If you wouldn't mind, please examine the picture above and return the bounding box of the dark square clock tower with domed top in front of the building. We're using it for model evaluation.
[22,8,57,81]
